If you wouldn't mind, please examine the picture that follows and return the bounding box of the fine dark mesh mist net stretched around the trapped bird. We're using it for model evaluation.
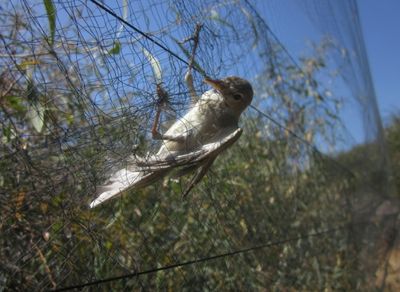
[0,0,394,291]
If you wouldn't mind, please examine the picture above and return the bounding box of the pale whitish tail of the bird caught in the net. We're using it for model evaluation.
[89,169,167,208]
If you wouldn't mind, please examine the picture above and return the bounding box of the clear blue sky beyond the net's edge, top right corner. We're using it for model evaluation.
[358,0,400,121]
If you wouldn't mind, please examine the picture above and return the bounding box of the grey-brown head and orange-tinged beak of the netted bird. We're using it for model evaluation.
[204,76,254,115]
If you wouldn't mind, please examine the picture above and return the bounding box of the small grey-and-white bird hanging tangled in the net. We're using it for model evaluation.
[90,76,254,208]
